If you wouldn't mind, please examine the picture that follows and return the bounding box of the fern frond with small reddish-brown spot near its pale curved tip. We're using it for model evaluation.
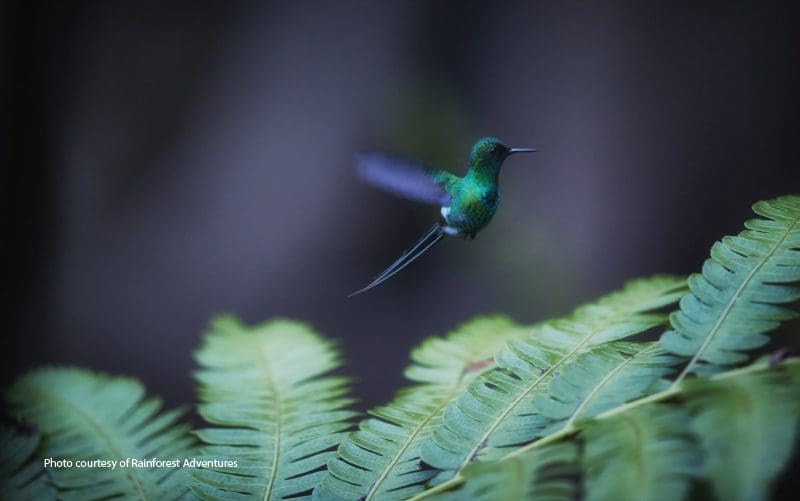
[315,317,530,500]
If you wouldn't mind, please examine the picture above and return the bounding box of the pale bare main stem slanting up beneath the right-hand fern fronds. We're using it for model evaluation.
[408,357,800,501]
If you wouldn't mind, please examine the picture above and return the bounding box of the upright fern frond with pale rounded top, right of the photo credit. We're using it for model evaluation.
[192,317,354,499]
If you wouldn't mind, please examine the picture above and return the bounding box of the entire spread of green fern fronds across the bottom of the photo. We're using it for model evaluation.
[0,196,800,500]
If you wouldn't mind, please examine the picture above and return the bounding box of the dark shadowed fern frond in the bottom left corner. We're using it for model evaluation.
[0,426,56,501]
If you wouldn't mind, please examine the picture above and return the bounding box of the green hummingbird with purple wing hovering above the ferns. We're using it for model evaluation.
[348,137,536,297]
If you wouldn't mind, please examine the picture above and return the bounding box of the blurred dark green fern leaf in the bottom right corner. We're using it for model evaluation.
[685,364,800,500]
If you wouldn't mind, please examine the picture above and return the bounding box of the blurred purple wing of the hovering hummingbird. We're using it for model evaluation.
[356,153,452,205]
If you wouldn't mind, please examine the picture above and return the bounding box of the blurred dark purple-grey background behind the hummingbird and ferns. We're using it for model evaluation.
[6,1,800,426]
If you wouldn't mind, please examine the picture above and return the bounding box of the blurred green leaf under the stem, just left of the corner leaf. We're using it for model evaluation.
[582,404,700,501]
